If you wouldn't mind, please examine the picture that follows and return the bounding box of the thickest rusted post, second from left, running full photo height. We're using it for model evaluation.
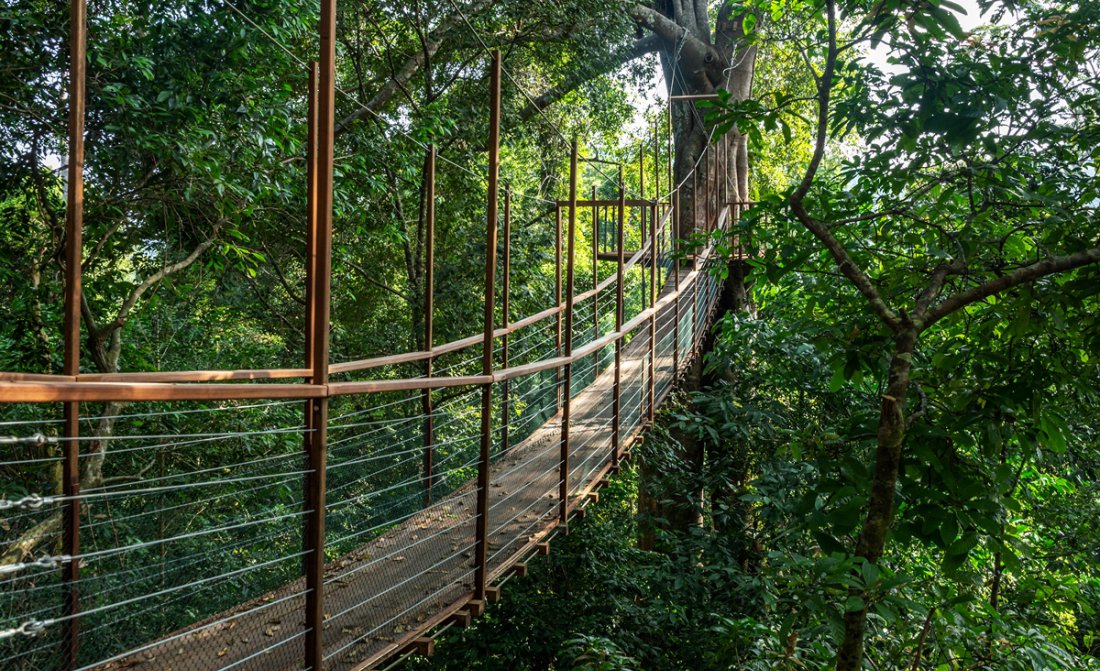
[305,0,337,671]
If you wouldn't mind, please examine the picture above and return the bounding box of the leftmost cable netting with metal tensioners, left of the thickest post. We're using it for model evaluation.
[0,402,306,669]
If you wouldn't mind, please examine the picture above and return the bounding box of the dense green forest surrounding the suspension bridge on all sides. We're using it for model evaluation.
[0,0,1100,671]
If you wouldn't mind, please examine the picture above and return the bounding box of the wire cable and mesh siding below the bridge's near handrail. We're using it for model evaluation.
[0,201,734,671]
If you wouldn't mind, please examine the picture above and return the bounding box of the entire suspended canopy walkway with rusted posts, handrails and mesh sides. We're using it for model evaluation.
[0,11,740,671]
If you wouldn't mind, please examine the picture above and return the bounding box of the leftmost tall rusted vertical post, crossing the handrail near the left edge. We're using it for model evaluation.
[61,0,88,669]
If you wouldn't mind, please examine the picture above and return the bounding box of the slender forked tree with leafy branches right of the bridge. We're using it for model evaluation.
[708,0,1100,671]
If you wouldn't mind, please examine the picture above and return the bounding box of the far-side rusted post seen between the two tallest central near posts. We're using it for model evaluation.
[420,144,436,504]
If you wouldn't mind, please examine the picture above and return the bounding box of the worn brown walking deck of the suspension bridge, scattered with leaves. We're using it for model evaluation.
[98,270,705,671]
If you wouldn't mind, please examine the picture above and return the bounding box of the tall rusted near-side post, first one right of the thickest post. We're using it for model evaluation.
[474,50,501,602]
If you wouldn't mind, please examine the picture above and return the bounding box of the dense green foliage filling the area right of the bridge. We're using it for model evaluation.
[413,3,1100,670]
